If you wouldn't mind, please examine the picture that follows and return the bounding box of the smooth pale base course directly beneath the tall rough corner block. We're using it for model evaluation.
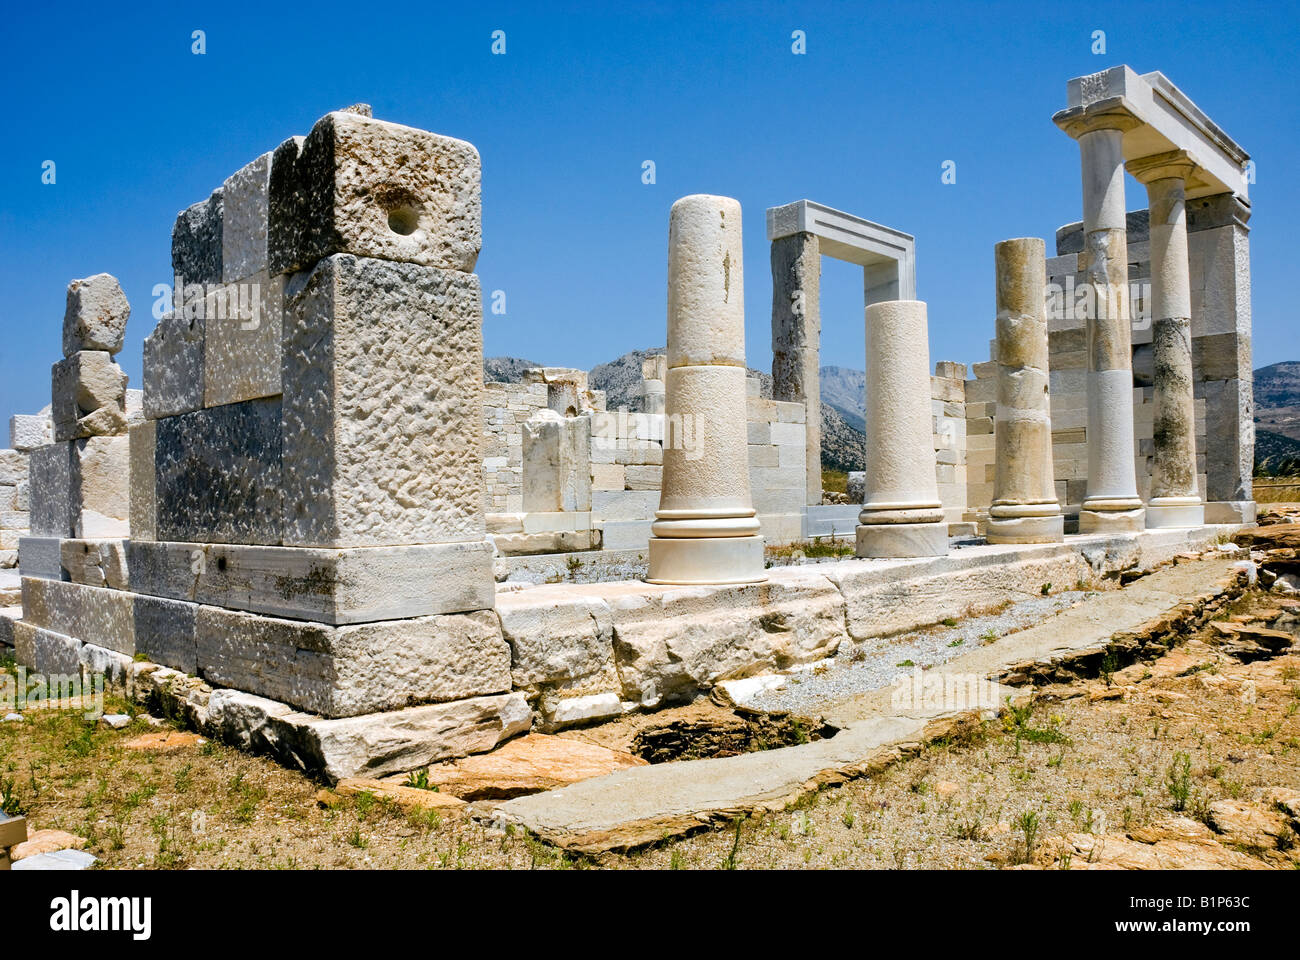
[129,541,495,624]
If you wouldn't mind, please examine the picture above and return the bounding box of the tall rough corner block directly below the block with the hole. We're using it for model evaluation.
[282,255,485,546]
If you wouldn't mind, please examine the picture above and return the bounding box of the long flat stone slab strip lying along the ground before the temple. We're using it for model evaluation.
[484,559,1236,853]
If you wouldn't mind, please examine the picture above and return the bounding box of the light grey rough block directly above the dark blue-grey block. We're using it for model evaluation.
[203,271,285,407]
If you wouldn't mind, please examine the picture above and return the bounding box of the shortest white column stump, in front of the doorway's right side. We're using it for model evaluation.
[857,300,948,557]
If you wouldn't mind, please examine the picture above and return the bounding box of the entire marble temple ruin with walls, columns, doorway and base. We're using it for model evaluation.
[0,66,1255,778]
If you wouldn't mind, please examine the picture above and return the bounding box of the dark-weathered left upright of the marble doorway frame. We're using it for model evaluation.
[772,233,822,505]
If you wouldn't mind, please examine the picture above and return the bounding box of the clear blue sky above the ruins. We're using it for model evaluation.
[0,1,1300,416]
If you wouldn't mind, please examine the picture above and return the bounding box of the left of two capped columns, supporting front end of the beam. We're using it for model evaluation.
[1062,105,1145,533]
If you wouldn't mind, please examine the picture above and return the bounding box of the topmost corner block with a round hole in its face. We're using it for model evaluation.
[268,112,482,273]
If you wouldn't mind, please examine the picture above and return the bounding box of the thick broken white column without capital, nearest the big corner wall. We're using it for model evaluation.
[646,194,767,583]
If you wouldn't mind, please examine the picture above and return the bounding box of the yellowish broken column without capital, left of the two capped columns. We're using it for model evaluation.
[988,237,1065,544]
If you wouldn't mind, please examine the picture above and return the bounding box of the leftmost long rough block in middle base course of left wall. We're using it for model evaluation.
[22,576,135,657]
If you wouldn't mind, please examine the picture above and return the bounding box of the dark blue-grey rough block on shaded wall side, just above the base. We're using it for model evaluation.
[153,399,283,544]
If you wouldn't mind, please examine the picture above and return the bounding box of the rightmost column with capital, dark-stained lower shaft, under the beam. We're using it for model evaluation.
[1128,150,1205,527]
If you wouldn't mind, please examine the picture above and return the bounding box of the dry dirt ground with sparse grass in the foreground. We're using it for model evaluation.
[0,582,1300,869]
